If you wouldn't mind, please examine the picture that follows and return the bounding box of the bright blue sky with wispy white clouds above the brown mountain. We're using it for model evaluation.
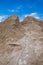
[0,0,43,22]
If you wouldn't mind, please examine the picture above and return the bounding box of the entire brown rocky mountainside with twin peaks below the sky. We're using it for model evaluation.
[0,15,43,65]
